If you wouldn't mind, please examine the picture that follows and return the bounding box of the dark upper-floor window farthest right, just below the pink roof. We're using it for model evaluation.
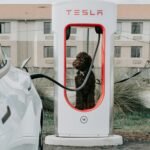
[131,22,143,34]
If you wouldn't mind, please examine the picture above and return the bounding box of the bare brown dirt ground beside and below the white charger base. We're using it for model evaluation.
[44,131,150,150]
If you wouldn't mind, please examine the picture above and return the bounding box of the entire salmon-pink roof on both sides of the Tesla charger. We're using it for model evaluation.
[0,4,150,20]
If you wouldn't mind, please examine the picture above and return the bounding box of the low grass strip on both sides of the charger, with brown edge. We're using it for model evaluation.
[43,110,150,141]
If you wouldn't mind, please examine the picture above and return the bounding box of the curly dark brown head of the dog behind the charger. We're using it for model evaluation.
[73,52,92,71]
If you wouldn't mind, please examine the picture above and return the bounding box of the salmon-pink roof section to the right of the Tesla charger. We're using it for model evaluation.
[118,4,150,20]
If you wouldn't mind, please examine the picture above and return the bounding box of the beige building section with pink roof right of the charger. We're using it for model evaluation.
[114,5,150,67]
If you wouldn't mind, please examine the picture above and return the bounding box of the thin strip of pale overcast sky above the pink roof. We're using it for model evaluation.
[0,0,150,4]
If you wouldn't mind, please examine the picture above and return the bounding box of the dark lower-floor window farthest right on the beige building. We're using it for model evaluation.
[131,46,142,58]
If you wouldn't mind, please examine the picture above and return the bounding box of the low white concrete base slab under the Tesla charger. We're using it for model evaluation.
[45,135,123,147]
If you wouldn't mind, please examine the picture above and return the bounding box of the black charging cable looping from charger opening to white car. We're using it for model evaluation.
[30,27,103,91]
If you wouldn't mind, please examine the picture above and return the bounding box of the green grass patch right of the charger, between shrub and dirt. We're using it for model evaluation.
[114,110,150,133]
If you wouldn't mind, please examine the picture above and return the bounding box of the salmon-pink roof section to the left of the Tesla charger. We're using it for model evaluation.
[0,4,51,20]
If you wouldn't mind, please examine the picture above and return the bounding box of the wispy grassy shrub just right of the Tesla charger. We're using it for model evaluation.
[114,82,146,113]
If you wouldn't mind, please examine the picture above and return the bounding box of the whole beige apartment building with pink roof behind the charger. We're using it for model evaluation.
[0,5,150,68]
